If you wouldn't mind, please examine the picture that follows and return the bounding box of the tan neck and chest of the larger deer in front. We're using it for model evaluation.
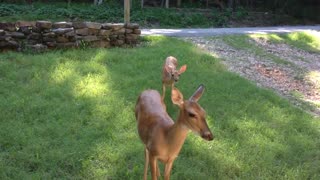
[168,111,189,153]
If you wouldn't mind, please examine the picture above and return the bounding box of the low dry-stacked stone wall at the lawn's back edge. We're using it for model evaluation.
[0,21,141,51]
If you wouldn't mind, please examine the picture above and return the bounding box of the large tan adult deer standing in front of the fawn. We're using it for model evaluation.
[135,85,213,180]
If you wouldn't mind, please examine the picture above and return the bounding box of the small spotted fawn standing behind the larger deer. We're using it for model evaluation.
[161,56,187,101]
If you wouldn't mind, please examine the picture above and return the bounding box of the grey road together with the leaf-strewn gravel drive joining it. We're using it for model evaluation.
[141,25,320,116]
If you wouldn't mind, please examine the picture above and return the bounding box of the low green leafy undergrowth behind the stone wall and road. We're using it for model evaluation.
[0,1,243,28]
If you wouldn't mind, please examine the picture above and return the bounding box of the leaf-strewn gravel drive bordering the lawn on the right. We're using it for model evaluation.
[185,32,320,116]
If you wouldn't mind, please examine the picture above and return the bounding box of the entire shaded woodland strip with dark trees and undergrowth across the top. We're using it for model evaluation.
[0,0,320,27]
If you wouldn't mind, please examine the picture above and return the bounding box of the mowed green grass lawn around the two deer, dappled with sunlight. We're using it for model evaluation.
[0,37,320,180]
